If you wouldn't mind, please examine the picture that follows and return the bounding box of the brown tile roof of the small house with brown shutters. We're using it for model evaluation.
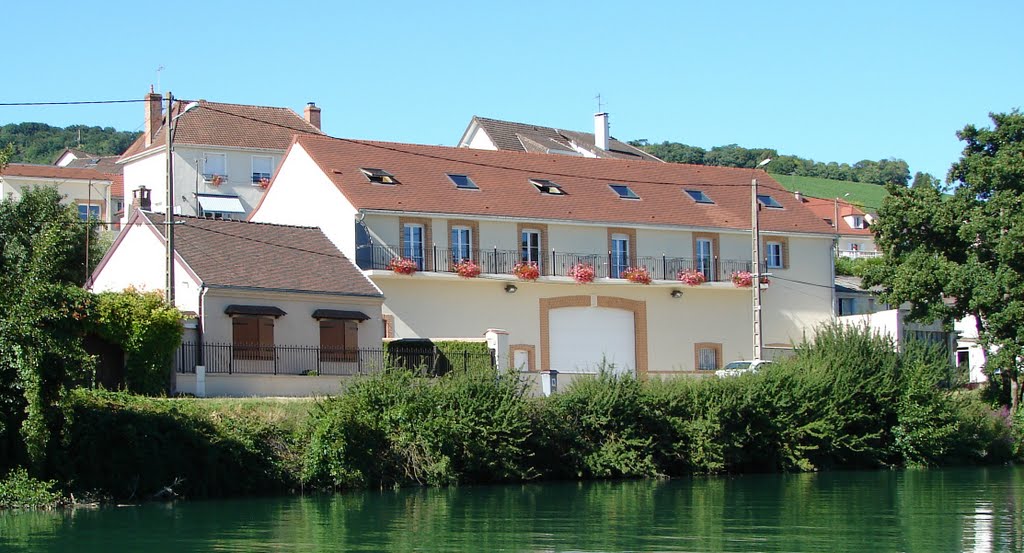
[143,212,381,297]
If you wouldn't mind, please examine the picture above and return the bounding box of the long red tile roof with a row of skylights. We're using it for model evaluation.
[284,135,831,233]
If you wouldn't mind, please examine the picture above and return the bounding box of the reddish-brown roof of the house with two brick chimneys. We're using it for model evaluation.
[121,100,323,160]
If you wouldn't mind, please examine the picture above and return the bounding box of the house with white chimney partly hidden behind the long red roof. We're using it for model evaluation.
[458,113,664,163]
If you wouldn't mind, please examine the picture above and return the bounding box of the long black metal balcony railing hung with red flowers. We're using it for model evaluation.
[355,244,752,283]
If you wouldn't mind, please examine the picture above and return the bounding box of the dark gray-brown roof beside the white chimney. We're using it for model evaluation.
[473,116,662,161]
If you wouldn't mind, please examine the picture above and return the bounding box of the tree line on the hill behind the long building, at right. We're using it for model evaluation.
[630,139,910,186]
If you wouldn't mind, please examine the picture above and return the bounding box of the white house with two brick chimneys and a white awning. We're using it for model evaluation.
[119,92,322,219]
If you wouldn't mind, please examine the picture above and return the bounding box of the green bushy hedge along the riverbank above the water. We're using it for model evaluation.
[9,329,1024,500]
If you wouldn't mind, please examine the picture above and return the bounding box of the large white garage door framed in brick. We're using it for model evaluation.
[548,307,636,374]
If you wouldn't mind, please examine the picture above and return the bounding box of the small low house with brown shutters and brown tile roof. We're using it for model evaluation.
[87,209,383,395]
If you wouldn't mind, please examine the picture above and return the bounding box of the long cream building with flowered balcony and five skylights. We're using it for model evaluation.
[250,135,833,377]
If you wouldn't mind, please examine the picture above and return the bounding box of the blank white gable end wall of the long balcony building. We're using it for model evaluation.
[249,144,360,254]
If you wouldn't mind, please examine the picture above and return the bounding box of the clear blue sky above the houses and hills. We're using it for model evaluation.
[0,0,1024,177]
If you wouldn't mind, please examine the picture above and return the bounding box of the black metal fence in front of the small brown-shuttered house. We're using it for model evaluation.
[174,342,495,376]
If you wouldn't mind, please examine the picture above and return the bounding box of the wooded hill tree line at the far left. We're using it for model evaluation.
[0,123,139,165]
